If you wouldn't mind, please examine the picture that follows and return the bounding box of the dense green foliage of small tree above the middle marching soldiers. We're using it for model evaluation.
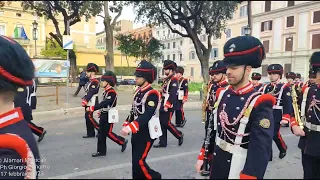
[116,34,163,62]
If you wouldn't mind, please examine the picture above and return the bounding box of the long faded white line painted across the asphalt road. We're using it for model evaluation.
[48,150,199,179]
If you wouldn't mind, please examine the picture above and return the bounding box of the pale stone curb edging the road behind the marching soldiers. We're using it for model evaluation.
[32,102,202,120]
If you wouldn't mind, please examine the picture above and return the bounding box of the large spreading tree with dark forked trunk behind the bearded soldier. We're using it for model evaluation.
[131,1,240,82]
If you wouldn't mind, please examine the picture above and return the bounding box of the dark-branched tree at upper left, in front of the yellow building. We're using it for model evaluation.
[22,1,102,78]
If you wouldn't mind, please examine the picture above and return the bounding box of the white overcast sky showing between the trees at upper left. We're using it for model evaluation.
[96,6,144,33]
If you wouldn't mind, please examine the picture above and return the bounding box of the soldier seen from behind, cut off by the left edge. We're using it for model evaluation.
[0,36,40,179]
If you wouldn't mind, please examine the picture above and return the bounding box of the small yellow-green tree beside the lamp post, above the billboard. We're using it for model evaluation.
[40,37,67,59]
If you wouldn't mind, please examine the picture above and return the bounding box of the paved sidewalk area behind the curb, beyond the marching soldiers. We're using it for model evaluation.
[35,86,200,112]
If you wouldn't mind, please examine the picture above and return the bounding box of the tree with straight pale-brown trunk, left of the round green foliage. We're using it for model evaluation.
[98,1,127,71]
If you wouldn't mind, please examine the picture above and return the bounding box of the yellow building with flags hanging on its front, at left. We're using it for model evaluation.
[0,1,96,57]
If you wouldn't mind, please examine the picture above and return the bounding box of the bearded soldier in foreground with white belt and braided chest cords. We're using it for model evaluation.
[196,36,275,179]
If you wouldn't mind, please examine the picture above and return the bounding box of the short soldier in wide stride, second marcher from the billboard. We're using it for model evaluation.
[87,71,128,157]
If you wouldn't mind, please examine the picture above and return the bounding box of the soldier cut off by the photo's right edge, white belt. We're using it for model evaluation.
[290,51,320,179]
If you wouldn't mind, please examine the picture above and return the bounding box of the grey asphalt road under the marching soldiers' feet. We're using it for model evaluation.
[31,109,303,179]
